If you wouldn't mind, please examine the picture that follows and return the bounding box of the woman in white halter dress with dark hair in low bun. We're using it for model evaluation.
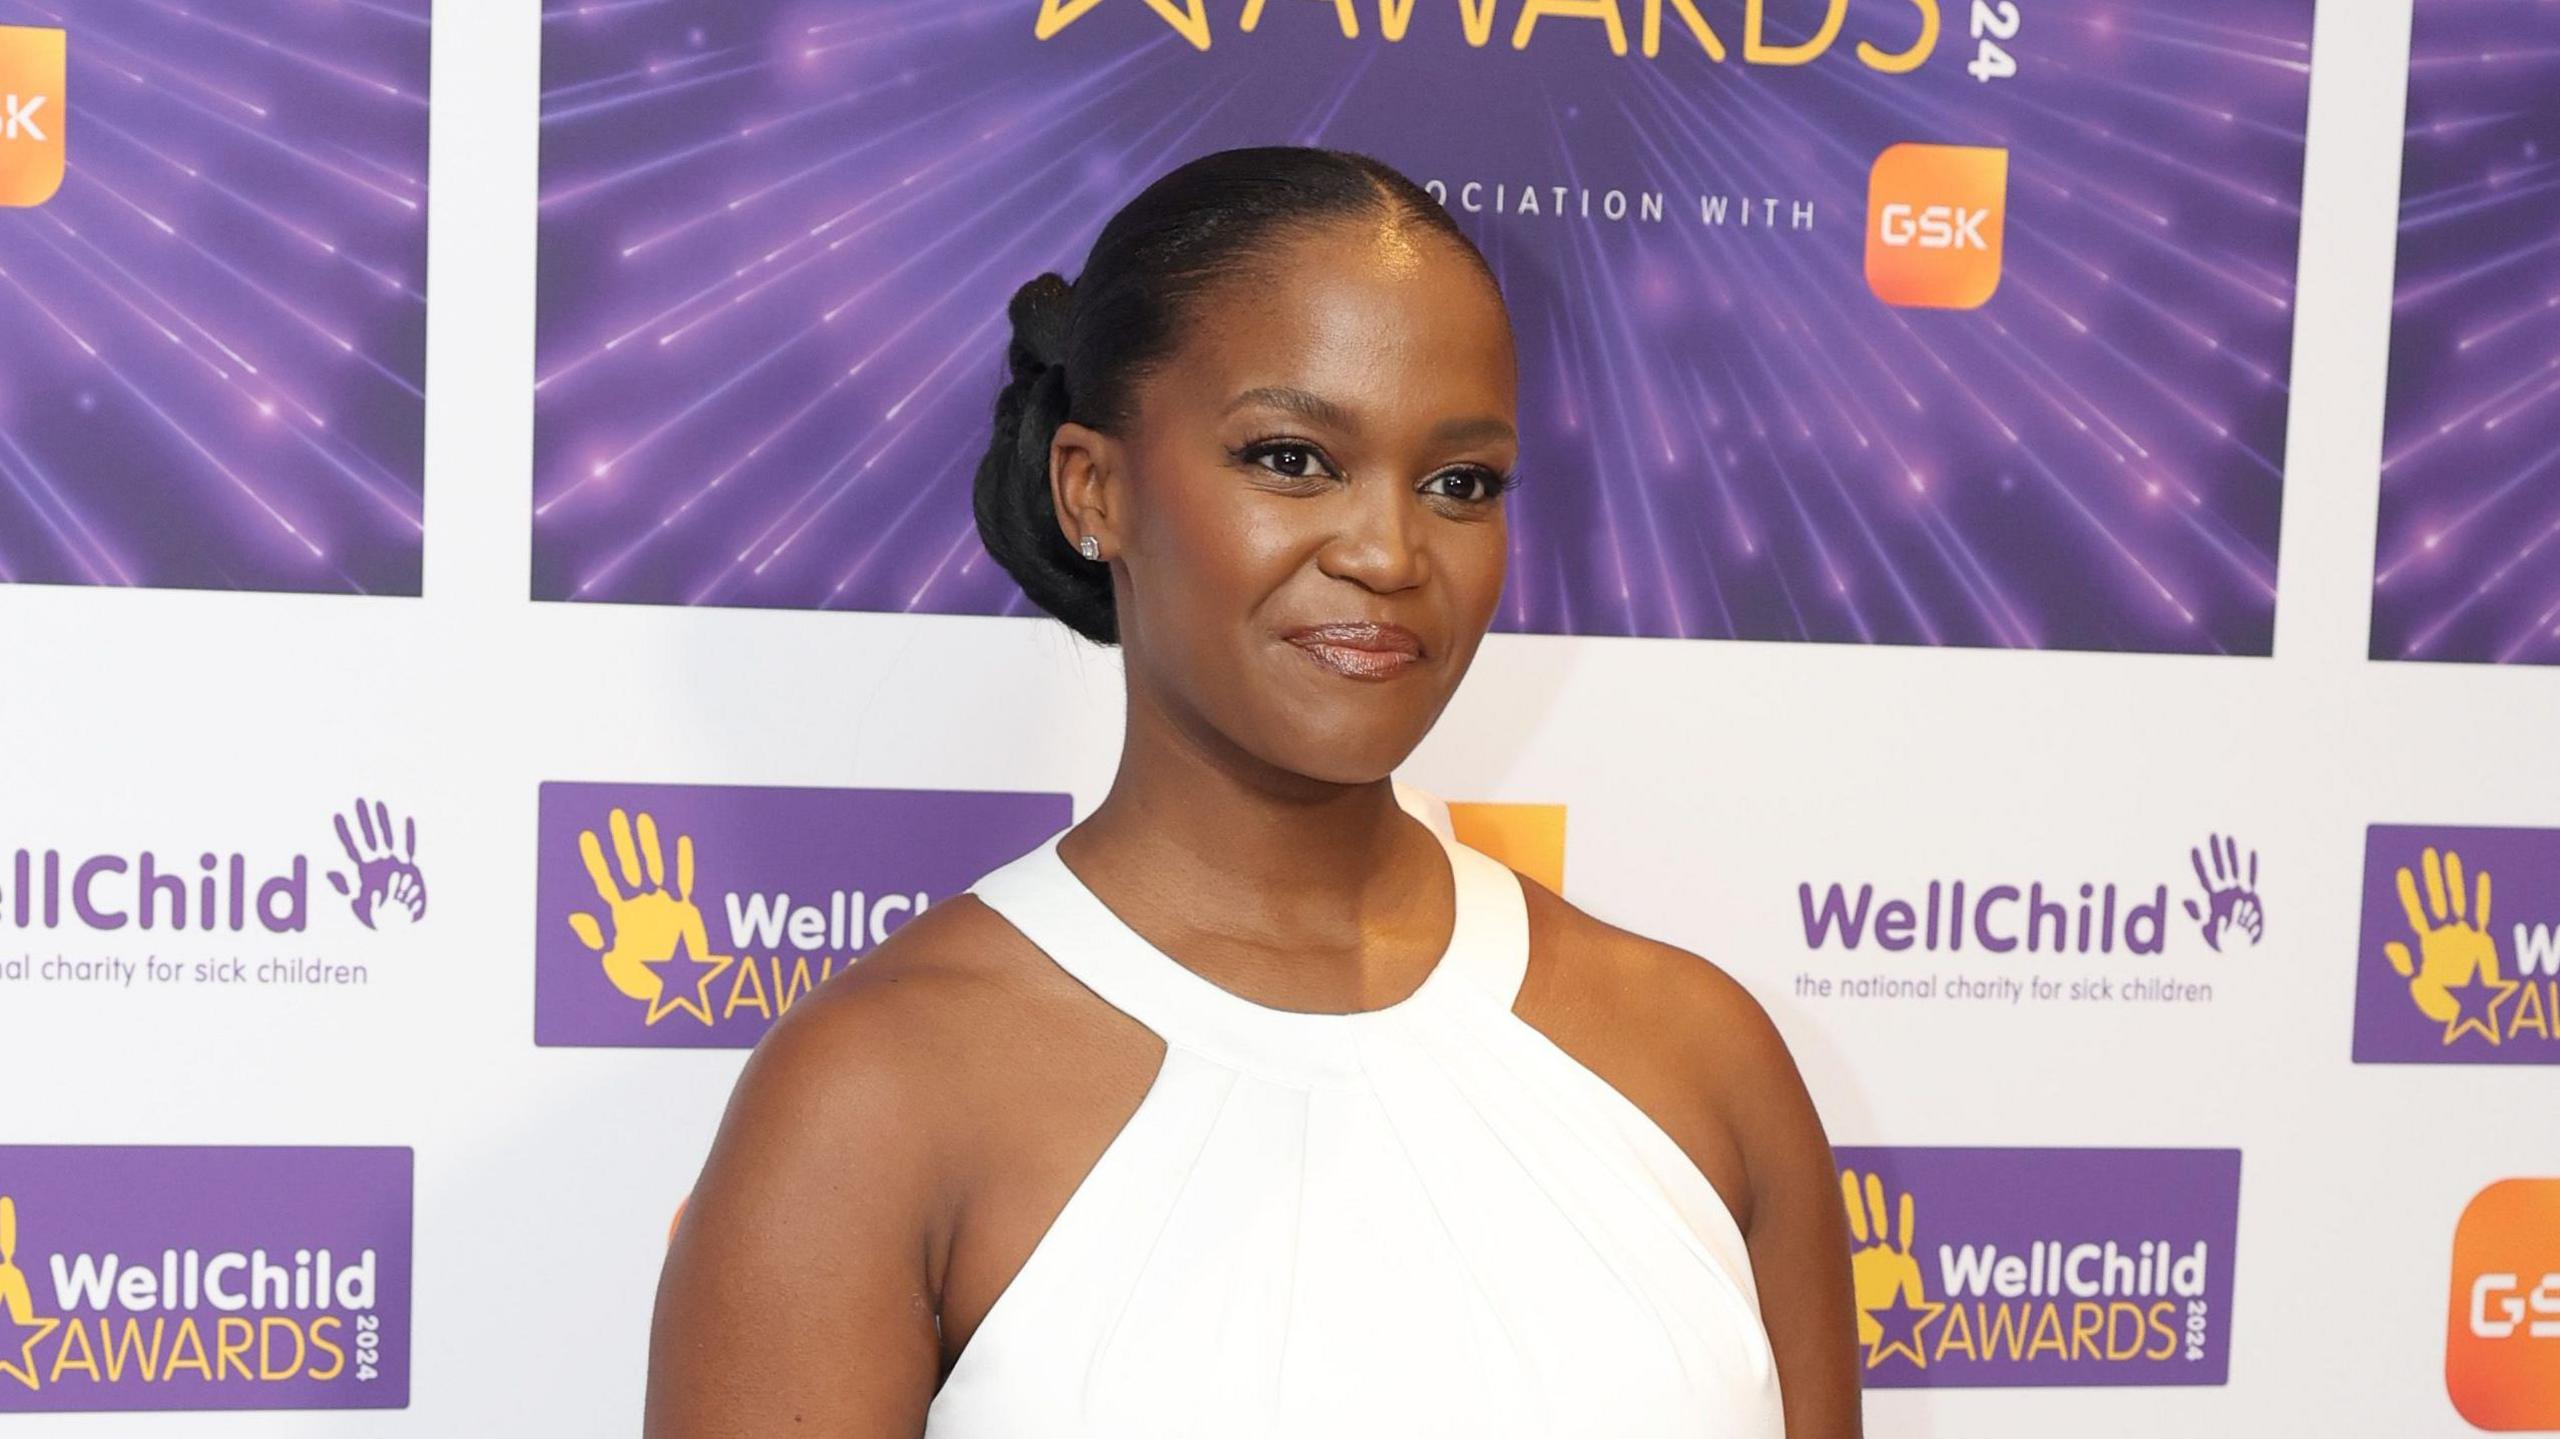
[648,146,1859,1439]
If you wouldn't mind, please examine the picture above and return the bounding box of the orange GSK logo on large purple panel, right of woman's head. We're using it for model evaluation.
[1866,146,2010,310]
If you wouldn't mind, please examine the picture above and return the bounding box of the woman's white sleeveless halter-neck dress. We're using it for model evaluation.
[924,784,1784,1439]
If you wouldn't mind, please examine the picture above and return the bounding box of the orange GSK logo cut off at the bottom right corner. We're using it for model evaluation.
[2445,1180,2560,1431]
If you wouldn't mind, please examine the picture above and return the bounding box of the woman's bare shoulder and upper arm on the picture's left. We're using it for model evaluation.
[648,894,1131,1434]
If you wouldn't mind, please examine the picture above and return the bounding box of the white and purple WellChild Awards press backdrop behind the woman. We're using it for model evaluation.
[0,0,2560,1439]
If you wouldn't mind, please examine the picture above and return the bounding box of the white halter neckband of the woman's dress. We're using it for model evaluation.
[973,788,1528,1086]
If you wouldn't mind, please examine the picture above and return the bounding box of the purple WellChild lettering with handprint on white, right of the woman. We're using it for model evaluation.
[1795,835,2266,1004]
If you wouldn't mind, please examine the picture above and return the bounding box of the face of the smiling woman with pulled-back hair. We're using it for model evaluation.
[1078,220,1518,784]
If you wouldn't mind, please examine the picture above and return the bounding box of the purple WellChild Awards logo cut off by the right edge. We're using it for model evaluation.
[2355,824,2560,1065]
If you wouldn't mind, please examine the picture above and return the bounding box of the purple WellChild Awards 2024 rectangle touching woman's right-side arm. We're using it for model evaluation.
[1836,1147,2240,1388]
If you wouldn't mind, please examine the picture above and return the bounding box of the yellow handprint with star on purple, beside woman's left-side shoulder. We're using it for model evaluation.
[568,807,737,1024]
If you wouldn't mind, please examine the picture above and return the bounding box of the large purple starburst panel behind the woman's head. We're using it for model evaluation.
[532,0,2312,655]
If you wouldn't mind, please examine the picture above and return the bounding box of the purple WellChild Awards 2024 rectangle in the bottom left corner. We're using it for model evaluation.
[0,1145,412,1413]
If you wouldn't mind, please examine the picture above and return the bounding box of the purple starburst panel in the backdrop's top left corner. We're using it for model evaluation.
[0,0,430,594]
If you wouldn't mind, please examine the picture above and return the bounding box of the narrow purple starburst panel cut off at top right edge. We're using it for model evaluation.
[2371,0,2560,666]
